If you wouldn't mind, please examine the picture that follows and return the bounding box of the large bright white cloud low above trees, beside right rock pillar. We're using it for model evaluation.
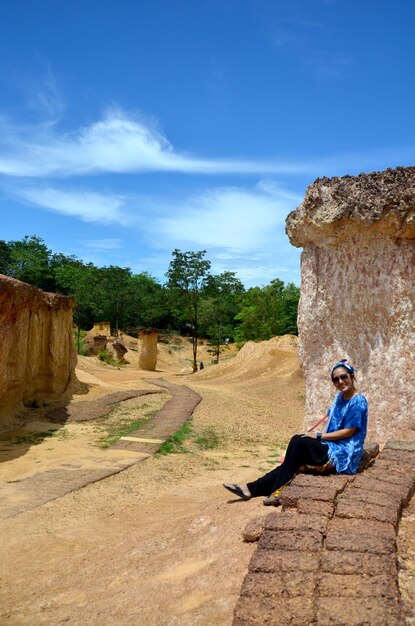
[136,180,301,286]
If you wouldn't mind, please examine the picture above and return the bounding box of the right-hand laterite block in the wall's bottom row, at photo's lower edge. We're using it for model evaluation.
[315,597,404,626]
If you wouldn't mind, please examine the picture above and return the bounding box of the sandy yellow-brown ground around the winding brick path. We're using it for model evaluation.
[0,337,414,626]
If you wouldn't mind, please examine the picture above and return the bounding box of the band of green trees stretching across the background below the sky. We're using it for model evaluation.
[0,236,300,367]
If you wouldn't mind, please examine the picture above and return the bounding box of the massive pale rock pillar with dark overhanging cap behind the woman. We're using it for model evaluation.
[286,167,415,441]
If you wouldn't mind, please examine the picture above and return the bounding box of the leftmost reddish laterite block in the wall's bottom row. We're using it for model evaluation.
[233,596,314,626]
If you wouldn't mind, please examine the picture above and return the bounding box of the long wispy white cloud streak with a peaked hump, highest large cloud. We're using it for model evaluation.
[0,109,314,177]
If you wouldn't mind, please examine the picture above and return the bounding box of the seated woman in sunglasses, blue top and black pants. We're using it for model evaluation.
[223,360,368,506]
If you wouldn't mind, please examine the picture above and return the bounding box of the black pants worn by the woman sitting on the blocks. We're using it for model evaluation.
[248,435,329,498]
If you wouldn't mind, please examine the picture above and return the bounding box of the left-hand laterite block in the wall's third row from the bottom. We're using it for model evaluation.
[249,547,321,573]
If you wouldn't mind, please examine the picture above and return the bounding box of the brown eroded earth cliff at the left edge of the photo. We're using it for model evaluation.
[0,275,79,430]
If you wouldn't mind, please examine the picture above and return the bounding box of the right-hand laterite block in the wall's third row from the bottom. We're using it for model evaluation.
[321,550,397,576]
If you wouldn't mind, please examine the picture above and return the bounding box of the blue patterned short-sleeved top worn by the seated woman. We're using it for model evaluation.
[322,392,368,474]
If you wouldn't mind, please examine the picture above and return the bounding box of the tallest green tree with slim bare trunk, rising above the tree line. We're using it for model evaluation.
[166,248,211,372]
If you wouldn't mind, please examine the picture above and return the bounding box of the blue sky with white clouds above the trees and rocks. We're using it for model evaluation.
[0,0,415,286]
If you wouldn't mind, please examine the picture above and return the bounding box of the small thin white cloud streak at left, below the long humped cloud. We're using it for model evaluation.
[16,187,127,225]
